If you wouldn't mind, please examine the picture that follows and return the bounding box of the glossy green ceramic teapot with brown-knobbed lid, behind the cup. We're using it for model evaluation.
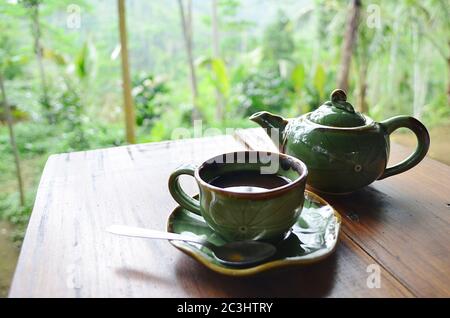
[250,89,430,194]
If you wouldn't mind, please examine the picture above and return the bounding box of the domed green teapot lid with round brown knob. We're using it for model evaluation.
[308,89,366,127]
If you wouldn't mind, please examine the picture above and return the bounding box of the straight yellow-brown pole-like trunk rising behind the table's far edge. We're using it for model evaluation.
[117,0,136,144]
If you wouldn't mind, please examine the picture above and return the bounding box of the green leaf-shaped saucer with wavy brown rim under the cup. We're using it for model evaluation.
[167,191,341,276]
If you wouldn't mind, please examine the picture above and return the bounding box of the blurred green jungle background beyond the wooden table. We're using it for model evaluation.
[0,0,450,296]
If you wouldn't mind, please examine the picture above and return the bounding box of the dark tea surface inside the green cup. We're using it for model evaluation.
[209,170,292,193]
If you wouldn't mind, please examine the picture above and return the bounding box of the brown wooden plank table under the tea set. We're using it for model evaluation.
[10,129,450,297]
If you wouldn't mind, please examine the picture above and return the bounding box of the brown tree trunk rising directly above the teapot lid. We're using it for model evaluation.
[337,0,361,91]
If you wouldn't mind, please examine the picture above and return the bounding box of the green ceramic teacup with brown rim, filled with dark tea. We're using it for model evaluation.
[169,151,308,241]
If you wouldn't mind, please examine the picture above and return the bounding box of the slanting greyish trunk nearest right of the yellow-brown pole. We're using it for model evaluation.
[178,0,200,122]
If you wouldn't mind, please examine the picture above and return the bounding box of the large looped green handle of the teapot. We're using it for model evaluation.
[378,116,430,180]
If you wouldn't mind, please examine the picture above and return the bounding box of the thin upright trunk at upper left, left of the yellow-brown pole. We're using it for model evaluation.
[31,4,51,123]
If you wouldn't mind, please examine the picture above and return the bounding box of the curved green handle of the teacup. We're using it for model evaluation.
[169,165,201,215]
